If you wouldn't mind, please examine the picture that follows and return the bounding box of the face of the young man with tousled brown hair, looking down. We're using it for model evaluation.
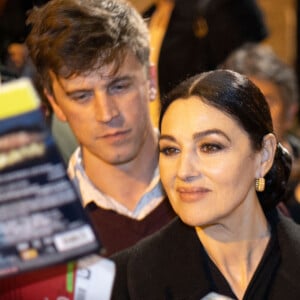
[47,53,152,165]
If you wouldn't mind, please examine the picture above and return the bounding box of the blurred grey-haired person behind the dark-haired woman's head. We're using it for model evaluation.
[220,43,300,223]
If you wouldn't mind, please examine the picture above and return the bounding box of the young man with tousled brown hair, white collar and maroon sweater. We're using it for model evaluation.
[26,0,174,256]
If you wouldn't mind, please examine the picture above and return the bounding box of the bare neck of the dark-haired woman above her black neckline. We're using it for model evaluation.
[196,206,270,299]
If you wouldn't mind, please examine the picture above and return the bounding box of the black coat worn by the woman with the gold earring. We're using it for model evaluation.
[112,215,300,300]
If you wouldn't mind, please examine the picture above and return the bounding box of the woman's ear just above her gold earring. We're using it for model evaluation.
[256,133,277,178]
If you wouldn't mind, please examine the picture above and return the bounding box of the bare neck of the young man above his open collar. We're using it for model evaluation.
[83,129,158,210]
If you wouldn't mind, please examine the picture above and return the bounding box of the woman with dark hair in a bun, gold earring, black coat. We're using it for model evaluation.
[113,70,300,300]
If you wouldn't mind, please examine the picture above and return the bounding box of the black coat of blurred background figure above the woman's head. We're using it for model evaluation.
[144,0,268,95]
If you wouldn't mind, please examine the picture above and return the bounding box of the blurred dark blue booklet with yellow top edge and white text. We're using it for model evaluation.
[0,79,101,278]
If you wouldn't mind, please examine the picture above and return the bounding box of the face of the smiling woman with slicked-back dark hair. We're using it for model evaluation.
[159,96,264,226]
